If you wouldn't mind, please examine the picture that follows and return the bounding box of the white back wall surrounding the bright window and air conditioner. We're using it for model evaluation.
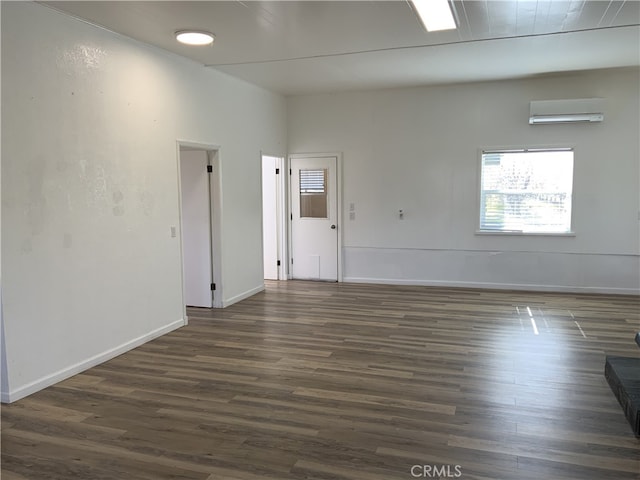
[287,70,640,293]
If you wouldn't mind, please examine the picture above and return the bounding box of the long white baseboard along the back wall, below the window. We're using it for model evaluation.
[343,277,640,295]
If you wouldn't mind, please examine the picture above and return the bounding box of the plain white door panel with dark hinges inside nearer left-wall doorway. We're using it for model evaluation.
[180,150,212,308]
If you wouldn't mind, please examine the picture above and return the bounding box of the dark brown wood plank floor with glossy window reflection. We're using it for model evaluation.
[2,281,640,480]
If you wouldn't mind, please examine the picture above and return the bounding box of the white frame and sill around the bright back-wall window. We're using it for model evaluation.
[475,144,576,237]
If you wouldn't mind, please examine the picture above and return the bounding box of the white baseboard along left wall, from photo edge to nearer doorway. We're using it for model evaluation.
[0,318,186,403]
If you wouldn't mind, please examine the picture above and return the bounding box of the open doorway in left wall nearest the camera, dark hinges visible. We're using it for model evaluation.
[178,141,222,314]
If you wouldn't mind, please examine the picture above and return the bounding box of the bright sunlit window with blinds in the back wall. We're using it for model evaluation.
[480,148,573,234]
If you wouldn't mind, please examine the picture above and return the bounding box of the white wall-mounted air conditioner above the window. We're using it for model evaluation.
[529,98,604,125]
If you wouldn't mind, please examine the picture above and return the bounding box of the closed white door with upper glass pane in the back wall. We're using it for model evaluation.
[291,156,338,282]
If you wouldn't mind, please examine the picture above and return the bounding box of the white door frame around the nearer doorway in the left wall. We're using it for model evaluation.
[176,139,224,316]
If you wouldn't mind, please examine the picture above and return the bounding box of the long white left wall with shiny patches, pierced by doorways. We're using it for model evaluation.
[2,2,286,401]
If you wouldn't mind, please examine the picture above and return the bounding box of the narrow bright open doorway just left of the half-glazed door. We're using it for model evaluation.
[262,155,287,280]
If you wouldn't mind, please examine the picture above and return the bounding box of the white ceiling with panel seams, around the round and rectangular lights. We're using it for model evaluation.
[44,0,640,95]
